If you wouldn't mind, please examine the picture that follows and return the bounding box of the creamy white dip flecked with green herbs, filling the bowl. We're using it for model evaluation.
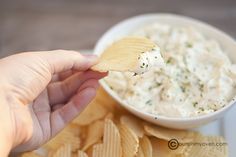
[105,23,236,117]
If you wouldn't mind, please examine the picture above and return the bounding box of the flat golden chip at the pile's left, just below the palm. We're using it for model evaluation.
[44,125,81,151]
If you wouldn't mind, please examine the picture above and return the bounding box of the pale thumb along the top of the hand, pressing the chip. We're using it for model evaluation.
[36,50,97,74]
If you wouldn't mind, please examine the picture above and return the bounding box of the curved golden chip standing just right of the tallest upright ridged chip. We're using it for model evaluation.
[119,124,139,157]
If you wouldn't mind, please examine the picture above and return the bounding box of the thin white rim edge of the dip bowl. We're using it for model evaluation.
[94,13,236,122]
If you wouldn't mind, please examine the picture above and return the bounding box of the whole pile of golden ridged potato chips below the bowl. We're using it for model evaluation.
[22,89,228,157]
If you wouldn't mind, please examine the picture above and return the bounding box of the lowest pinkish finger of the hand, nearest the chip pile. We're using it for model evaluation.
[51,79,99,135]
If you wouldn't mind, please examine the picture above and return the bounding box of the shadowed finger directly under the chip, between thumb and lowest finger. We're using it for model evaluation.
[48,71,106,105]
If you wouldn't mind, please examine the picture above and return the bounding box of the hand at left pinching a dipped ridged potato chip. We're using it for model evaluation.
[0,50,106,154]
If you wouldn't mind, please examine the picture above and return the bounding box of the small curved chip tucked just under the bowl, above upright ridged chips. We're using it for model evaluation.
[120,115,144,138]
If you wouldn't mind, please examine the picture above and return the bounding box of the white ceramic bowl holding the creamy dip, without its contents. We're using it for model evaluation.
[94,14,236,129]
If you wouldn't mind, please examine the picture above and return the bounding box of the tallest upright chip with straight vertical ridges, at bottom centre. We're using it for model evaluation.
[93,119,122,157]
